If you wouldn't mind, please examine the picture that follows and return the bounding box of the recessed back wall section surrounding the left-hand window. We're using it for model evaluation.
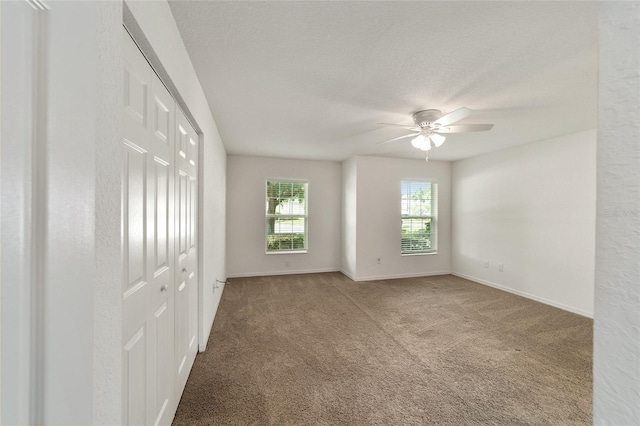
[227,155,341,277]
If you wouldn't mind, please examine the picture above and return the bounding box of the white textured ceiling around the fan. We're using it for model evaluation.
[170,1,598,161]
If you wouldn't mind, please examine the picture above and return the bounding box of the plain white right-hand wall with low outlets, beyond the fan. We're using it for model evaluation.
[452,130,596,316]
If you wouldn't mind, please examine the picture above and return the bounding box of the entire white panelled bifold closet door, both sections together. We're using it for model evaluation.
[122,31,198,425]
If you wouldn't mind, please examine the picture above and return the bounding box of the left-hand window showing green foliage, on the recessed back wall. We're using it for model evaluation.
[266,180,308,253]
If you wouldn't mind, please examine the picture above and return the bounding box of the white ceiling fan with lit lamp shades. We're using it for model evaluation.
[378,108,493,161]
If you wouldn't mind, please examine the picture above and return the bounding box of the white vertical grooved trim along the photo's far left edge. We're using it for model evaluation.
[0,1,49,424]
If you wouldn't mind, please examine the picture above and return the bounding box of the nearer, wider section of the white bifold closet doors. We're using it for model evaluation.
[122,31,179,424]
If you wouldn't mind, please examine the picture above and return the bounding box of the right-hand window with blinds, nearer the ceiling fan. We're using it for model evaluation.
[400,181,437,254]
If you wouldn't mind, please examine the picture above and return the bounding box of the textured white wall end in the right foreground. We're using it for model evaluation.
[593,2,640,425]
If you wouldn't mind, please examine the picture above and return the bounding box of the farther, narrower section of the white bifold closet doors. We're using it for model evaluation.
[175,110,198,395]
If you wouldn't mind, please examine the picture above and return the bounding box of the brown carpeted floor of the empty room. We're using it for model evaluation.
[174,273,592,425]
